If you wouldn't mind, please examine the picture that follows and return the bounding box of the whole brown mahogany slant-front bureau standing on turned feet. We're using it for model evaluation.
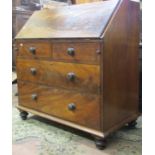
[16,0,139,149]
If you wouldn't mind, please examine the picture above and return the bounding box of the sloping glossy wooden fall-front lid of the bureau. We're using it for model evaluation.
[16,0,120,39]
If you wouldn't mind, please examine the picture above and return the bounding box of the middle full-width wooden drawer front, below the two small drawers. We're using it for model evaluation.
[17,59,100,93]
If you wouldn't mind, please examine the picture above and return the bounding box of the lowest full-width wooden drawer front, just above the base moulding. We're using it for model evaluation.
[19,82,100,130]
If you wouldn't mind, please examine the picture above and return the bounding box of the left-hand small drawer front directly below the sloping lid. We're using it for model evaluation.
[16,42,52,58]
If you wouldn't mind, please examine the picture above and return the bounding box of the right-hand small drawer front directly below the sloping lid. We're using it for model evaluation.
[53,42,101,64]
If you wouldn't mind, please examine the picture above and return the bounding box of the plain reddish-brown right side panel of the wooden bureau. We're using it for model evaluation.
[103,0,139,132]
